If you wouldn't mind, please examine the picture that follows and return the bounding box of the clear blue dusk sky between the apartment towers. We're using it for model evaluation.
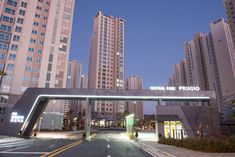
[70,0,226,113]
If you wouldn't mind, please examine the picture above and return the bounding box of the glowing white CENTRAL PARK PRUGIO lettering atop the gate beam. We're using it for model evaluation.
[149,86,200,91]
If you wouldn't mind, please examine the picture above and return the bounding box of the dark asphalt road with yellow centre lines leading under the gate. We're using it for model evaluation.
[0,131,154,157]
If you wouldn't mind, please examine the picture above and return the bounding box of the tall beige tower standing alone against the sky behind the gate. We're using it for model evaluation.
[88,12,125,121]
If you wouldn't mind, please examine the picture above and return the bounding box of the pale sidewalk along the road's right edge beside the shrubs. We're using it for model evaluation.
[133,140,235,157]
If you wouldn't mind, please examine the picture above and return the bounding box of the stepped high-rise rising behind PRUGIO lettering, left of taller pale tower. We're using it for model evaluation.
[184,33,214,90]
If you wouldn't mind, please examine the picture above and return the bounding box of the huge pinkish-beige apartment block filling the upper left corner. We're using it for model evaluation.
[0,0,75,126]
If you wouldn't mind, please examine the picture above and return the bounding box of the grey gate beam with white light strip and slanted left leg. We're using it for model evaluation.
[0,88,217,137]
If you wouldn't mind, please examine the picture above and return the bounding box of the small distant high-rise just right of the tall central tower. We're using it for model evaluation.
[125,76,144,120]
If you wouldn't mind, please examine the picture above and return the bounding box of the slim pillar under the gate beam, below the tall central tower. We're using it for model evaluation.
[85,99,94,141]
